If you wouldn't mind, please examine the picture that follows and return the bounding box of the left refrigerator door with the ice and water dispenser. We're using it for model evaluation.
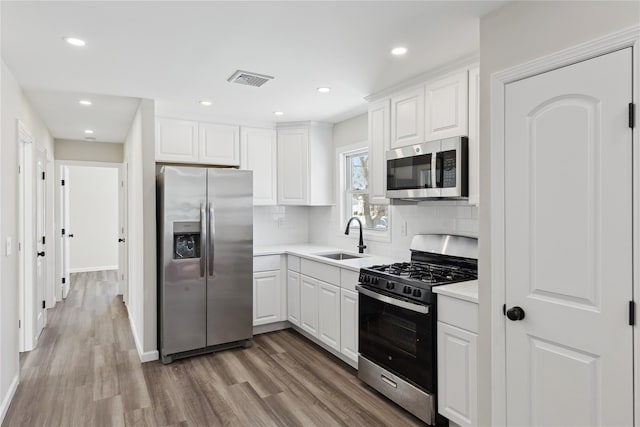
[158,166,207,357]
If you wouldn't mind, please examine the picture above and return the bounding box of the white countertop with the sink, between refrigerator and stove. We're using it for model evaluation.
[253,243,408,271]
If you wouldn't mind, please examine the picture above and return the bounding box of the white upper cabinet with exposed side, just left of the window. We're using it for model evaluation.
[277,122,333,206]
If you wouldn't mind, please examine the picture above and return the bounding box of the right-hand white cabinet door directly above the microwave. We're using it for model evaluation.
[425,70,468,141]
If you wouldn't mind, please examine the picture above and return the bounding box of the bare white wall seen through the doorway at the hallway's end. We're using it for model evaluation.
[68,166,119,273]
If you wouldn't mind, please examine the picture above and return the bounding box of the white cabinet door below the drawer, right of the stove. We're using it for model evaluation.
[438,322,478,426]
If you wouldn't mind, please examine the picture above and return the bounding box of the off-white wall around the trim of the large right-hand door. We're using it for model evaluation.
[478,1,640,425]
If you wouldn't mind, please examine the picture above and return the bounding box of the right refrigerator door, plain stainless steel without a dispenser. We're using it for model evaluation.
[207,169,253,346]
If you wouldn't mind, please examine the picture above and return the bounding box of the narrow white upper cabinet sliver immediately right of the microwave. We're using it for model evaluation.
[469,67,480,205]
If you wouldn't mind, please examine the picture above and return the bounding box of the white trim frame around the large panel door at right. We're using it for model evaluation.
[492,25,640,426]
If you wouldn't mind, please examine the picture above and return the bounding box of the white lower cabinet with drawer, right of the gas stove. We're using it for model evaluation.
[437,295,478,426]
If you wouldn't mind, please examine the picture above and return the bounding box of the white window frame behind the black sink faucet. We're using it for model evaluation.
[336,141,391,242]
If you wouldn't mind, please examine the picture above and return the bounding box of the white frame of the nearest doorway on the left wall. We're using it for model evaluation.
[16,120,36,352]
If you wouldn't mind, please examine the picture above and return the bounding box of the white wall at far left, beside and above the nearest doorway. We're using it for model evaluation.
[0,61,54,422]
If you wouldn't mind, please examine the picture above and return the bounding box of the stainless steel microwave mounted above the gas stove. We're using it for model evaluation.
[387,136,469,200]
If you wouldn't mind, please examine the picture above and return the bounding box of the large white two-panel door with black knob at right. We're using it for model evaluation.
[504,48,633,426]
